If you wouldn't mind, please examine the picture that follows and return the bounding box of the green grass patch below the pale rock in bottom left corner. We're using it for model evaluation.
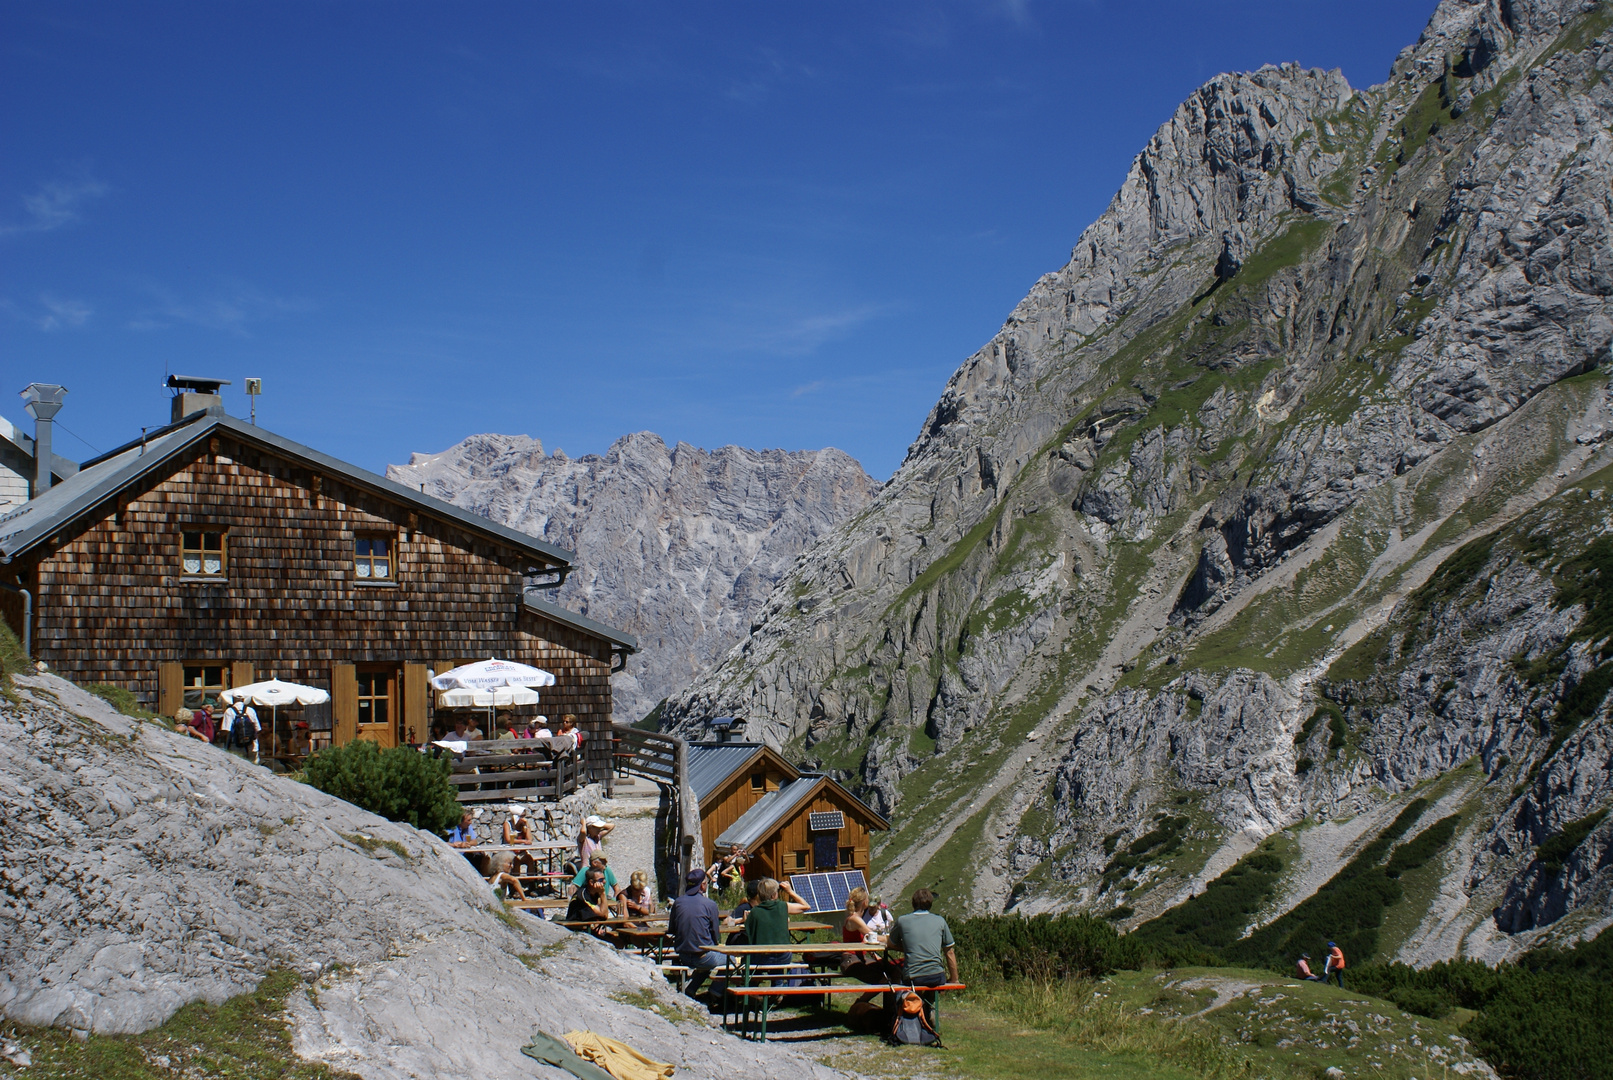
[0,970,356,1080]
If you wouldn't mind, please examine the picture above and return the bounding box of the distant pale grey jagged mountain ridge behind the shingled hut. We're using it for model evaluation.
[387,432,879,722]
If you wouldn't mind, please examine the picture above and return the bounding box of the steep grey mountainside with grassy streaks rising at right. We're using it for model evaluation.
[666,0,1613,959]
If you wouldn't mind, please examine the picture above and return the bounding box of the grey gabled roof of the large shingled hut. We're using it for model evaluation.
[0,409,581,570]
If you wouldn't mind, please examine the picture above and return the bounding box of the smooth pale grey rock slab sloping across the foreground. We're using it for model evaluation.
[0,675,839,1080]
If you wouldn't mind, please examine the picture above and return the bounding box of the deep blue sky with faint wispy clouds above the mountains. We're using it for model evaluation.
[0,0,1432,479]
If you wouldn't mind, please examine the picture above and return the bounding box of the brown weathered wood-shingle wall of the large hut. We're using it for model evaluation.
[18,435,629,760]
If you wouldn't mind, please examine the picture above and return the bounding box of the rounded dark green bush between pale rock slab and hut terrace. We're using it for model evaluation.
[303,738,461,833]
